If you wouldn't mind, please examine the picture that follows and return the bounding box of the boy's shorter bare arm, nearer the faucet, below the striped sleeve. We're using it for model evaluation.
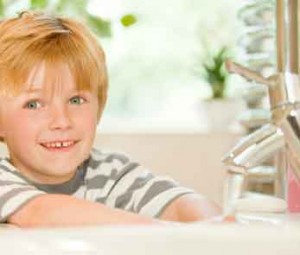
[160,194,221,222]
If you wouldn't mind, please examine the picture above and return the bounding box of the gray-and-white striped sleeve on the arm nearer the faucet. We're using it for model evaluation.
[106,152,194,217]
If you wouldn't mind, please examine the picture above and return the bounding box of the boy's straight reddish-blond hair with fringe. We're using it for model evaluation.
[0,11,108,116]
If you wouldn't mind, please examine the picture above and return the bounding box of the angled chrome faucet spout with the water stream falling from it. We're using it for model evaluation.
[223,124,285,215]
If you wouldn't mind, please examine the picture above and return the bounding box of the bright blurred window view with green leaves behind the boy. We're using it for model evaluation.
[0,0,239,125]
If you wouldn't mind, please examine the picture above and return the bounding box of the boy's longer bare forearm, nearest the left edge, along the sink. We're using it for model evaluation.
[8,194,156,228]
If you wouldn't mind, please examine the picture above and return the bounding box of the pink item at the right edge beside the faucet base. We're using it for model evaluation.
[287,170,300,213]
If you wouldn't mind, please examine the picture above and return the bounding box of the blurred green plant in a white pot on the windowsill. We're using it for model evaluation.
[201,46,241,131]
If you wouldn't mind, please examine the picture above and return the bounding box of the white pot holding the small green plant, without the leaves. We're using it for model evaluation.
[200,98,244,131]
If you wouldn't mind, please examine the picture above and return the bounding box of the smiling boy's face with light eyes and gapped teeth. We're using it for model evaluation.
[0,64,98,184]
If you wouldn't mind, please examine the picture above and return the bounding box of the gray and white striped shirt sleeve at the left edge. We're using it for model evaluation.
[0,160,45,223]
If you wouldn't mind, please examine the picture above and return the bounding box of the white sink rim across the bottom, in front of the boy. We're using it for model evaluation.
[0,215,300,255]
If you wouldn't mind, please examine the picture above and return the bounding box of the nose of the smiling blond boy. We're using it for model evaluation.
[50,105,72,130]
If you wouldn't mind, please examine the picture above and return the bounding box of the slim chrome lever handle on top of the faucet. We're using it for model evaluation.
[225,59,273,86]
